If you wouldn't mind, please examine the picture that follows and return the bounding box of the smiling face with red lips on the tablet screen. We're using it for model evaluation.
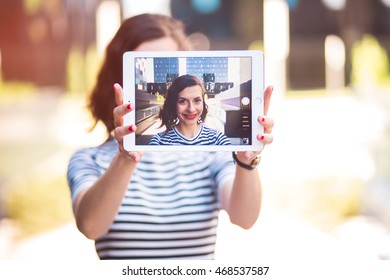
[176,85,203,126]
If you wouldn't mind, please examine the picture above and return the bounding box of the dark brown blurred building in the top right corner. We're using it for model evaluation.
[287,0,390,88]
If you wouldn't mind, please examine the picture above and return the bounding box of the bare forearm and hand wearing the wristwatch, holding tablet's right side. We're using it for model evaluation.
[222,87,274,229]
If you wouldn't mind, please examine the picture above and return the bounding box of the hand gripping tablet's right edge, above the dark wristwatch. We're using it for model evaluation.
[237,86,274,164]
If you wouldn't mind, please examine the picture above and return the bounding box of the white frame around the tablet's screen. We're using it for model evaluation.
[123,50,264,151]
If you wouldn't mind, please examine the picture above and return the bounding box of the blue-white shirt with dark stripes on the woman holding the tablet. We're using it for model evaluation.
[67,140,235,259]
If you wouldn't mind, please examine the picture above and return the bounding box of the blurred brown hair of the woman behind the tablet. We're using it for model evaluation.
[87,14,190,133]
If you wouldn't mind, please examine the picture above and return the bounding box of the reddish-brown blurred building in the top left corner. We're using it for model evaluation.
[0,0,99,86]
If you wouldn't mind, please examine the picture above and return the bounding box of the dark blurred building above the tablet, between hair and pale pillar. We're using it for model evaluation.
[171,0,263,50]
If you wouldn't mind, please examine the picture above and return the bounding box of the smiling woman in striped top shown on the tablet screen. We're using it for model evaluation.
[149,74,230,145]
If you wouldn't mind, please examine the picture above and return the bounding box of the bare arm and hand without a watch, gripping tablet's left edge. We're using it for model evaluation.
[73,84,142,239]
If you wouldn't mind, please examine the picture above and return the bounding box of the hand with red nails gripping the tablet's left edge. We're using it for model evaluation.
[113,83,142,162]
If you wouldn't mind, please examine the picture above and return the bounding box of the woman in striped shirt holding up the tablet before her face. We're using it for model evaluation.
[68,14,273,259]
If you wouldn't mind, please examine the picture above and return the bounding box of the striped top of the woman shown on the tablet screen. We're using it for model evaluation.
[149,124,231,146]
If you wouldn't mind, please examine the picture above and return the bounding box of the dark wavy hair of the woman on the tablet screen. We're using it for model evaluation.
[158,74,208,131]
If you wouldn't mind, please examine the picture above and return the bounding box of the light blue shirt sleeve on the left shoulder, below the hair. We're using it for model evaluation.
[67,149,101,202]
